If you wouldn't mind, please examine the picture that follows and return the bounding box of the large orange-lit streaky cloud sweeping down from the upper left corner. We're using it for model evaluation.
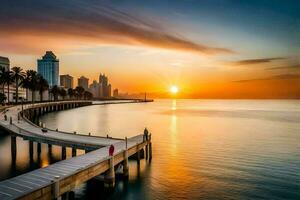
[0,0,233,54]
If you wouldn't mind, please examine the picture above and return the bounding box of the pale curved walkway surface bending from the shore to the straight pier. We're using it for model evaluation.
[0,101,138,150]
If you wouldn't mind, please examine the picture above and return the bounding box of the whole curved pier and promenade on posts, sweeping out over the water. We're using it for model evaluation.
[0,101,152,199]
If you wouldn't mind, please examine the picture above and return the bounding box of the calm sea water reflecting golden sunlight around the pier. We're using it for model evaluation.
[0,100,300,199]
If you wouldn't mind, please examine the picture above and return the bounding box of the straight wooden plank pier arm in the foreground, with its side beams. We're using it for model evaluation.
[0,135,146,200]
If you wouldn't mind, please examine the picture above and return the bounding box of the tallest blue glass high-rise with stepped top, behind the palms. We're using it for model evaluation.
[37,51,59,87]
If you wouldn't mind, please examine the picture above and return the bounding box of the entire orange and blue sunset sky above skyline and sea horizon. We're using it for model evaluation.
[0,0,300,98]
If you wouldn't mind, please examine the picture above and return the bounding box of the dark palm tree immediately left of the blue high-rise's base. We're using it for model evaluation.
[22,70,38,103]
